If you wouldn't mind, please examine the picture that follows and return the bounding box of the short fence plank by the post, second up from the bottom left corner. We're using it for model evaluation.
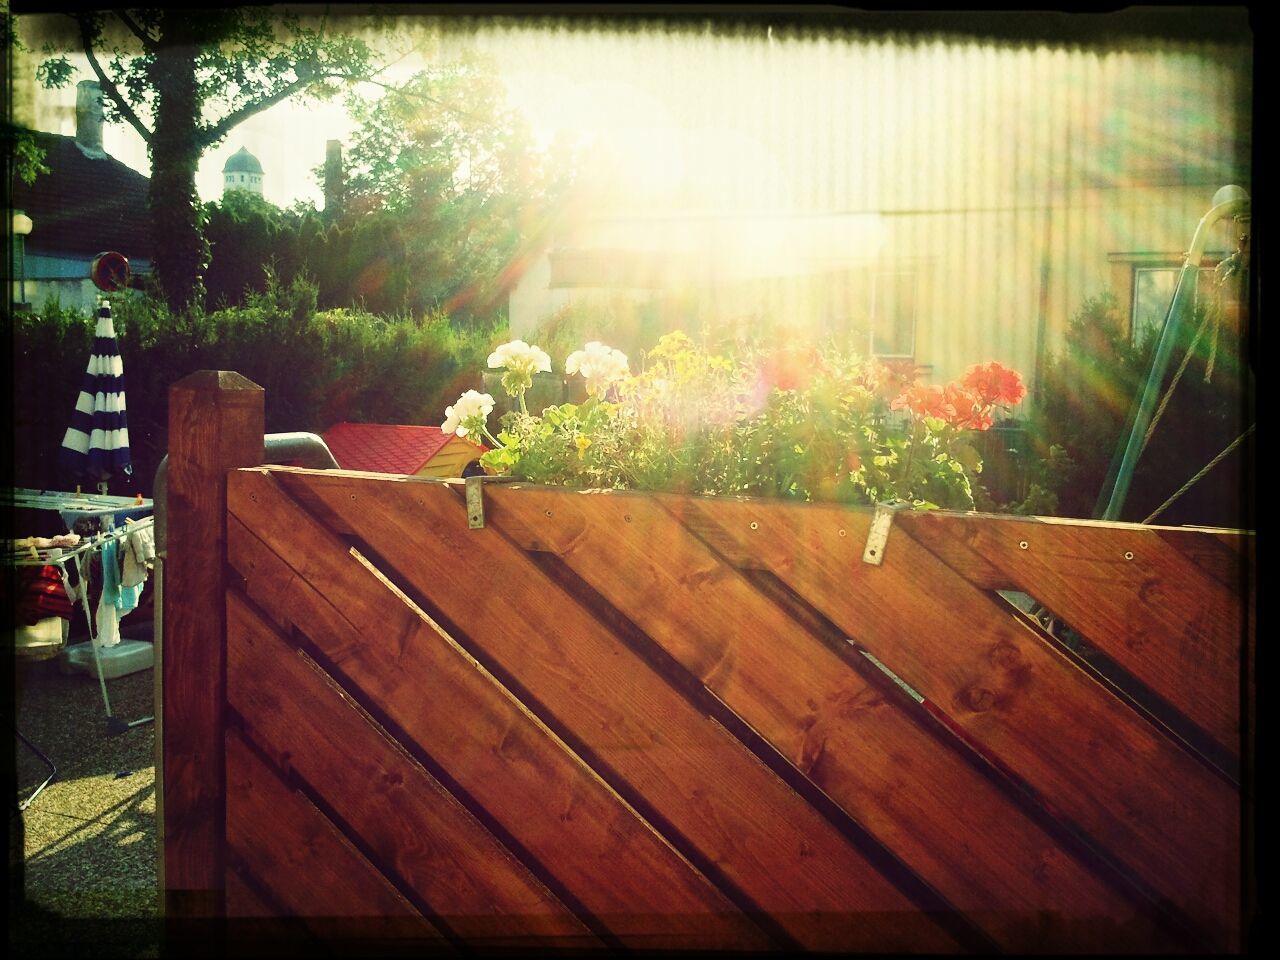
[227,730,444,950]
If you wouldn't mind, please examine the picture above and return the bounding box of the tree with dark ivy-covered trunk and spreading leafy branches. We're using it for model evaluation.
[40,8,374,310]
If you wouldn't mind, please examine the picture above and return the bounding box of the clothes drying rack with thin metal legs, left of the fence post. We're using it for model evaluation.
[9,488,155,733]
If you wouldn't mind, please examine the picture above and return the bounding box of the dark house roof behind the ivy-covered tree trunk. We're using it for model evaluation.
[9,131,152,259]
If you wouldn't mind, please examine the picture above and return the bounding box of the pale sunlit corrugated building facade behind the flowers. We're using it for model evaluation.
[509,38,1252,407]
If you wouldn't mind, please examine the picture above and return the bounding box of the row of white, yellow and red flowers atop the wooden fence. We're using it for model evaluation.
[442,332,1027,509]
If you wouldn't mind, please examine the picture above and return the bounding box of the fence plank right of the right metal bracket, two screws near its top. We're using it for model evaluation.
[897,511,1243,756]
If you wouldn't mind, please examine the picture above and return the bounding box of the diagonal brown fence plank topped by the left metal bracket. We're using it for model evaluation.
[278,475,957,952]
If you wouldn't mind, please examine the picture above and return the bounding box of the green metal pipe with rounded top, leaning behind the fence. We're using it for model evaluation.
[1101,187,1249,520]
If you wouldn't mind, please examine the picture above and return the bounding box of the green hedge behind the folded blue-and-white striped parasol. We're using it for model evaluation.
[13,271,506,495]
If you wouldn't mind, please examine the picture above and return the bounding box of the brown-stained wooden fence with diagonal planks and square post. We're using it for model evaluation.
[161,374,1253,952]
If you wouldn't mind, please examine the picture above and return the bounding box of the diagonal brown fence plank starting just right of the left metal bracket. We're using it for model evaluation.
[476,488,1176,951]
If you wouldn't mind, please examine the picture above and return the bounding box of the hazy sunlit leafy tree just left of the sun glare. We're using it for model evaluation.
[346,52,572,321]
